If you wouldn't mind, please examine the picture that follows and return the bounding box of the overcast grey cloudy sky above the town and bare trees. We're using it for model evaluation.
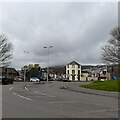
[2,2,118,69]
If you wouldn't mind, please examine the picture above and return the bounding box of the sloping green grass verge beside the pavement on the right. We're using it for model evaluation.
[80,79,120,92]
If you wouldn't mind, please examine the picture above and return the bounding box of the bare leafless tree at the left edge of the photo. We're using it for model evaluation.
[0,34,13,67]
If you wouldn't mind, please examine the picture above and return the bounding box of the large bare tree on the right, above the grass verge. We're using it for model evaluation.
[102,27,120,75]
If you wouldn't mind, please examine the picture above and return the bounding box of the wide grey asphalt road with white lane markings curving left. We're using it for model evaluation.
[2,82,118,118]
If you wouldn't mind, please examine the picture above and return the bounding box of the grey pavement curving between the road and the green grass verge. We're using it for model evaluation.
[62,82,120,98]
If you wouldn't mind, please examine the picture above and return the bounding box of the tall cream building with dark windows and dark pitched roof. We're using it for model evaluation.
[66,61,81,81]
